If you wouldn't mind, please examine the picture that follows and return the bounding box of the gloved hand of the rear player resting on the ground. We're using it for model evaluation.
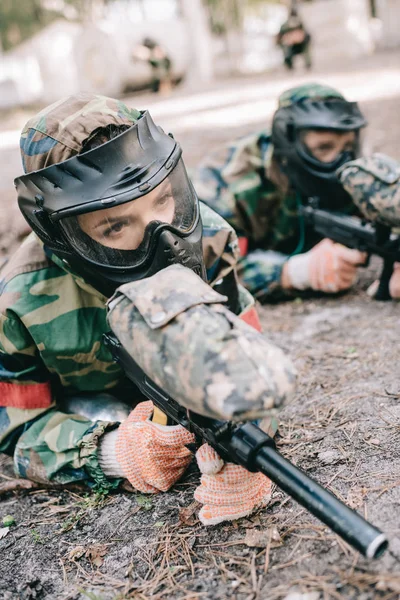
[282,239,366,293]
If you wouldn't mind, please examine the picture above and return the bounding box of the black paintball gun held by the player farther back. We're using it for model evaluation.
[300,198,400,300]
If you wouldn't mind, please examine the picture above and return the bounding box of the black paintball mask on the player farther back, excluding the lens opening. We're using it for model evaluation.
[272,94,367,210]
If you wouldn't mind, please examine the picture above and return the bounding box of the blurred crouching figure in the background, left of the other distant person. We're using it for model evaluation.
[132,37,172,94]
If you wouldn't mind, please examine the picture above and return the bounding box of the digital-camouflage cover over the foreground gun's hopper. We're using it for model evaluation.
[108,265,295,421]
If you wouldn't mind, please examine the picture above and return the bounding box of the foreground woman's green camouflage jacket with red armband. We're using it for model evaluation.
[0,205,253,487]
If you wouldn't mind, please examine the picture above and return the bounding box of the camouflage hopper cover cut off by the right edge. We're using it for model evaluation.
[338,154,400,227]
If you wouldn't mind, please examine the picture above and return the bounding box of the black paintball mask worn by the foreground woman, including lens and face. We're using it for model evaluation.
[15,112,205,296]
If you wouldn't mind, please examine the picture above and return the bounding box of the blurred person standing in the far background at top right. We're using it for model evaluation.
[276,2,311,69]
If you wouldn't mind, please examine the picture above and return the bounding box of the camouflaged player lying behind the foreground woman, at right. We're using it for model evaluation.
[192,83,400,302]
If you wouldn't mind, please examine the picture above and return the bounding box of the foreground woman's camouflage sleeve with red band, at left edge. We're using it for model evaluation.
[0,311,118,488]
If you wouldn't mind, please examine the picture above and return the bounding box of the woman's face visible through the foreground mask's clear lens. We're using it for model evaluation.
[78,179,175,250]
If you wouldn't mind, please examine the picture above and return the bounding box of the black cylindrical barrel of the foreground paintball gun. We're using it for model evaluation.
[230,423,388,558]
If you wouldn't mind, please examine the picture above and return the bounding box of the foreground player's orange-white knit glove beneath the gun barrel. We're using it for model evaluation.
[194,444,271,525]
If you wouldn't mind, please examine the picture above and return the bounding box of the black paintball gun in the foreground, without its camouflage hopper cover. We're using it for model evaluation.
[104,333,388,558]
